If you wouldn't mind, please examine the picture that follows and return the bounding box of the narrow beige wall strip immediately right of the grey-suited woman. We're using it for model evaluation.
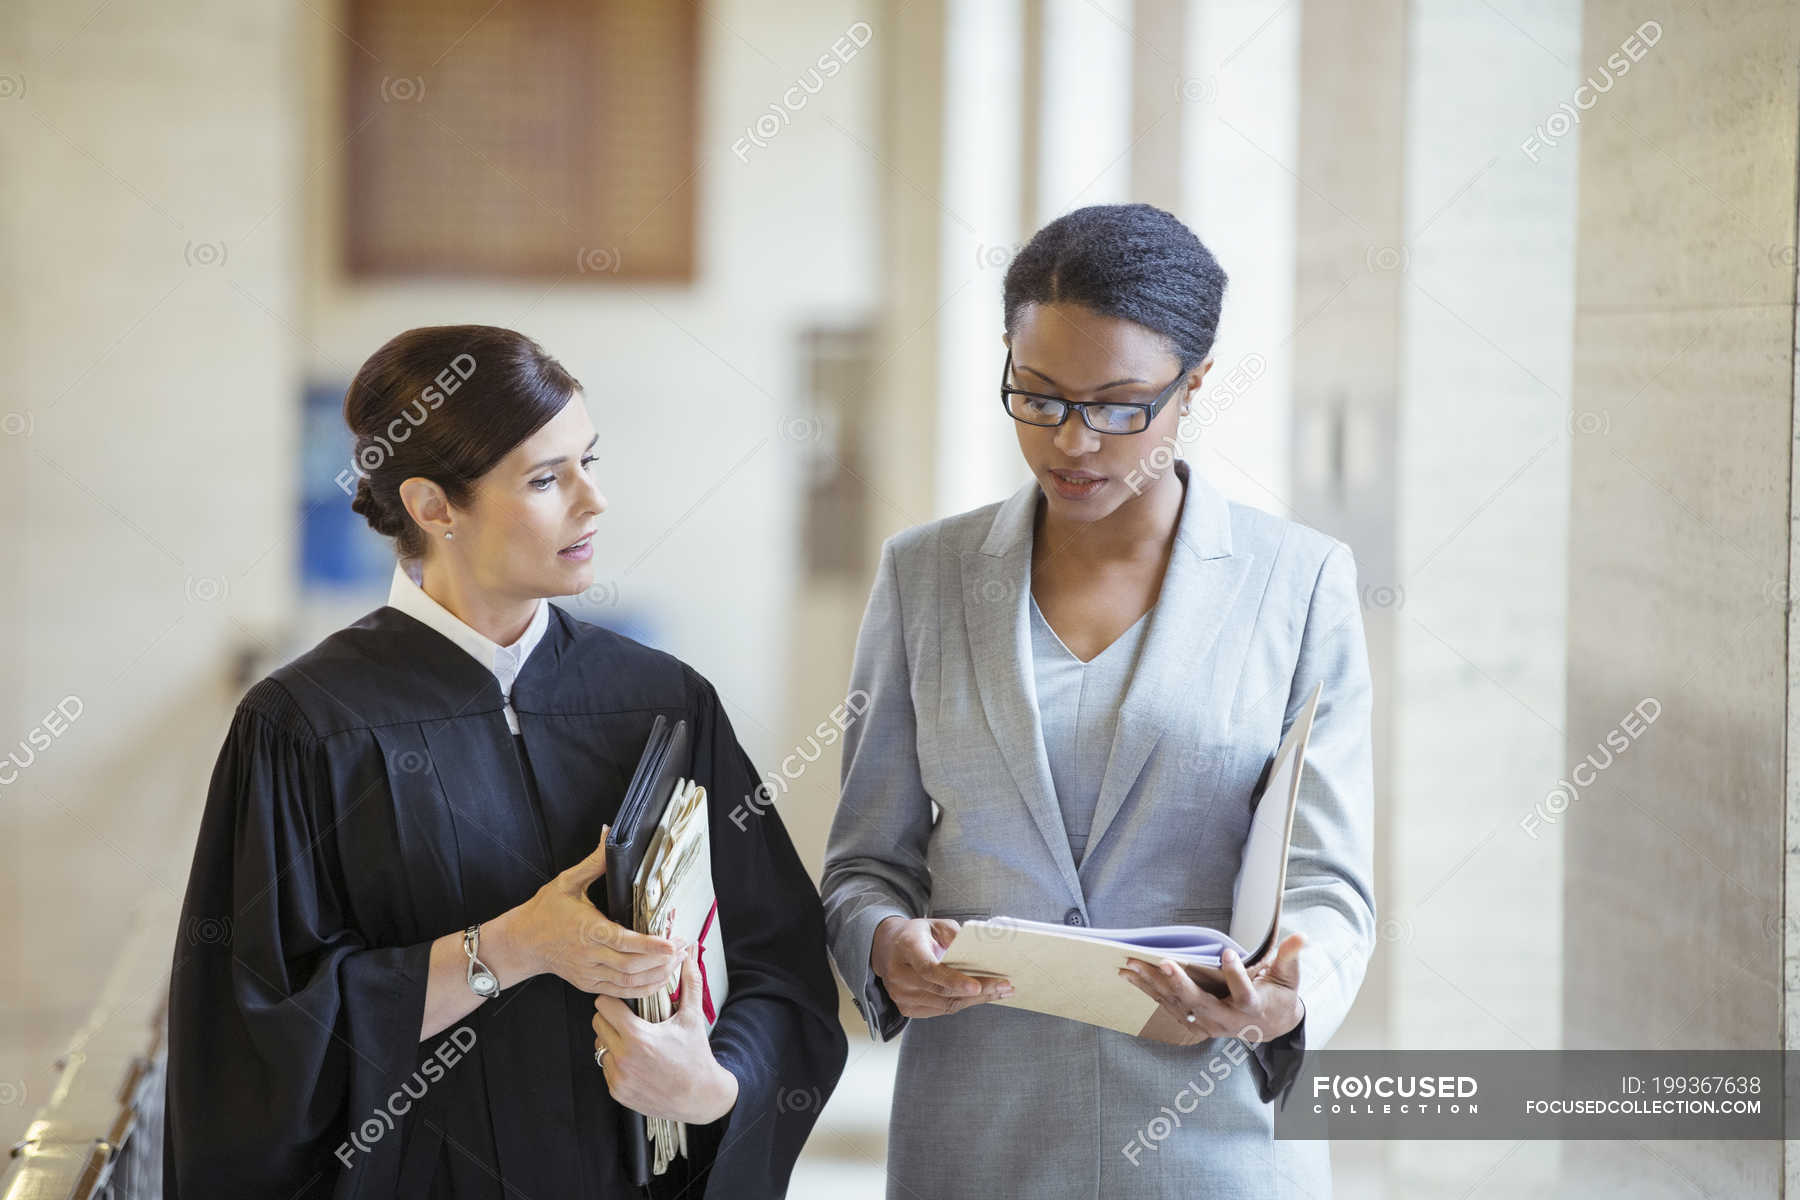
[1291,0,1406,1045]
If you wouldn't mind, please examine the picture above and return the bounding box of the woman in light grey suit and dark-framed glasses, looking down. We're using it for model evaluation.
[821,205,1375,1200]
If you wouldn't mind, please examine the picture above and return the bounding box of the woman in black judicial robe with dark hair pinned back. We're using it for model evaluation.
[164,326,846,1200]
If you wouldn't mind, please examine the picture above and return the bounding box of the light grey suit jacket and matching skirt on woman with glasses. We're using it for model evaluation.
[821,461,1375,1200]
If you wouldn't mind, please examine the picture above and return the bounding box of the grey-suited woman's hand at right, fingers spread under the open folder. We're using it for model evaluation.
[1120,934,1307,1045]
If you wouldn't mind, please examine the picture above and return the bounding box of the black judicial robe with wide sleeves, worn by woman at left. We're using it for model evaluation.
[164,601,846,1200]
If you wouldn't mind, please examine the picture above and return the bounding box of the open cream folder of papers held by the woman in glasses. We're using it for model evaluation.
[943,684,1323,1034]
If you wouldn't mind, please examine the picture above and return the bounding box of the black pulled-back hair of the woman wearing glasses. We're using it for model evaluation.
[1004,203,1226,371]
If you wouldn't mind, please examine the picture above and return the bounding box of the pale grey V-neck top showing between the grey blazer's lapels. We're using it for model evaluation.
[1030,596,1156,865]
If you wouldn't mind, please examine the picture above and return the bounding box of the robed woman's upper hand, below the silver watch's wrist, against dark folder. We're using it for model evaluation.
[502,829,682,999]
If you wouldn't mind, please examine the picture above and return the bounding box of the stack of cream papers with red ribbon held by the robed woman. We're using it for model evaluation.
[632,779,727,1175]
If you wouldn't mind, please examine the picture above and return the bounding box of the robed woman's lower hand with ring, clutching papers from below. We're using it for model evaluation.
[594,946,738,1124]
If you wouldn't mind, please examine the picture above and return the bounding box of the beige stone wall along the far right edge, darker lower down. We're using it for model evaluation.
[1562,0,1800,1196]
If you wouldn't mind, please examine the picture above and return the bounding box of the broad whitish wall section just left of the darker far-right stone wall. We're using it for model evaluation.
[1375,0,1580,1196]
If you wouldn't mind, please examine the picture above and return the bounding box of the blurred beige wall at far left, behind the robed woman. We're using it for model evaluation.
[0,2,310,1128]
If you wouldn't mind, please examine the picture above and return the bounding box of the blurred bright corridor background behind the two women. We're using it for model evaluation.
[0,0,1800,1198]
